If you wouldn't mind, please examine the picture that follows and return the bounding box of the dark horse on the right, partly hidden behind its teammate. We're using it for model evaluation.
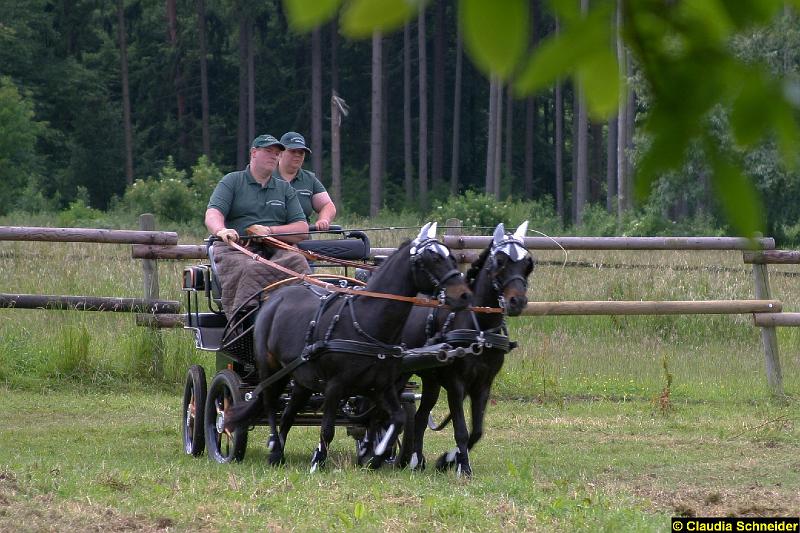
[401,222,533,476]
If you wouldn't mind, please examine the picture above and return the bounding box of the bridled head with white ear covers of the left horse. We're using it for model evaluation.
[409,222,472,311]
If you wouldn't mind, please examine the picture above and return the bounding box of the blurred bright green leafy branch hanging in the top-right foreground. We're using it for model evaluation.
[284,0,800,235]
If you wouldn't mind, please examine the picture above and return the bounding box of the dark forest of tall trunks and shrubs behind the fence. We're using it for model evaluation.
[0,0,800,243]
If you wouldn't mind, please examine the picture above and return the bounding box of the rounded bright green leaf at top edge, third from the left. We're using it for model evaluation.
[459,0,529,78]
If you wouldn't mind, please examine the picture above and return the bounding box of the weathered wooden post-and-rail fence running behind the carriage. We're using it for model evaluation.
[0,214,800,395]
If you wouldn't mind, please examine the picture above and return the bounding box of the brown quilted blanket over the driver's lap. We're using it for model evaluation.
[214,242,311,320]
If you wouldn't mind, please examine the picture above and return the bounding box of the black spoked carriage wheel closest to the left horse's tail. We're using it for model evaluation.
[204,368,247,463]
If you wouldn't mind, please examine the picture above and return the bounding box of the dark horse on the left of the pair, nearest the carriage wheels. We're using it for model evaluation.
[225,223,472,471]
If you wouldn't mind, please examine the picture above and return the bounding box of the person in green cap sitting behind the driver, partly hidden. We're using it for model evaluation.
[273,131,336,231]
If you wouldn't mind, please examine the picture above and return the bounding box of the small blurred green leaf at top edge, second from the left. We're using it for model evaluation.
[342,0,419,37]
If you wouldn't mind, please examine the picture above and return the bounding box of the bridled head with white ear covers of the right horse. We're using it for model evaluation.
[489,220,533,316]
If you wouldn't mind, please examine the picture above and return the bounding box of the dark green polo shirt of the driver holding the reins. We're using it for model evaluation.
[208,165,305,235]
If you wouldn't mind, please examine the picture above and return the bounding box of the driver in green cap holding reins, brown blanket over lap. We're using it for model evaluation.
[205,135,310,320]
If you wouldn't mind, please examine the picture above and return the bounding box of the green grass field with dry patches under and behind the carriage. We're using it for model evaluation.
[0,225,800,531]
